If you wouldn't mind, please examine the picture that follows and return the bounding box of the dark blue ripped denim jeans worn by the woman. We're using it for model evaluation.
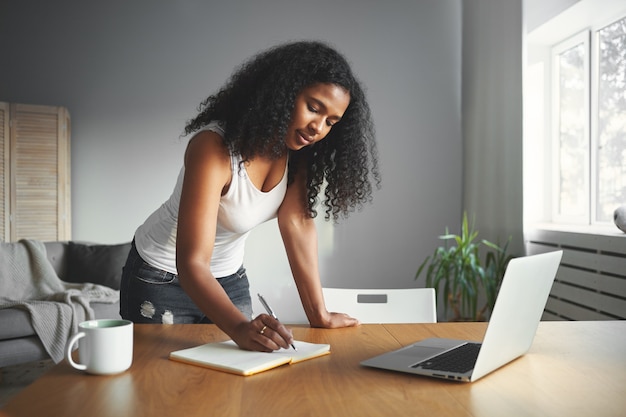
[120,242,252,324]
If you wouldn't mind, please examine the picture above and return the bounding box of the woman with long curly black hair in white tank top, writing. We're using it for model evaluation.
[120,42,379,351]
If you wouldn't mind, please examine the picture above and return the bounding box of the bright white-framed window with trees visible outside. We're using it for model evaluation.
[531,15,626,225]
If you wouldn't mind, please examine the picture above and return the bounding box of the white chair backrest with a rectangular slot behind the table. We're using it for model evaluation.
[323,288,437,323]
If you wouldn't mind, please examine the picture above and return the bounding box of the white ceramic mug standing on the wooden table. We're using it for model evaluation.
[65,319,133,375]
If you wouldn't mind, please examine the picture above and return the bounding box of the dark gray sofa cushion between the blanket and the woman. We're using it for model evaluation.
[64,242,130,290]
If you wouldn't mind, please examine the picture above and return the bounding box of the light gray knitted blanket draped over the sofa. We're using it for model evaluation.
[0,240,119,363]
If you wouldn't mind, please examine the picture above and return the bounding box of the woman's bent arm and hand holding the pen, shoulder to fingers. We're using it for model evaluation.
[176,132,292,351]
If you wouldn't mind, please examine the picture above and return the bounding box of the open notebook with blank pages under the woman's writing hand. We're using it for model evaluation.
[170,340,330,376]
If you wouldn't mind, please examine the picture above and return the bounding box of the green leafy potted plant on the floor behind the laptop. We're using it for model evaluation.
[415,213,512,321]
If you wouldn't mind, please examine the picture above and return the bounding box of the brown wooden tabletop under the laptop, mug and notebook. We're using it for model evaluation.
[0,321,626,417]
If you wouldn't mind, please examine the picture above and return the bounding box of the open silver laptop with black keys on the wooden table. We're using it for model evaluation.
[361,250,563,382]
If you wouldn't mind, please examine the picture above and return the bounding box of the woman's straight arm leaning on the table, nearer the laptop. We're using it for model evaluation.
[278,167,359,328]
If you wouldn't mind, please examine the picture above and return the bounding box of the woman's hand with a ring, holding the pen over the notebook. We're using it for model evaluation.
[233,314,293,352]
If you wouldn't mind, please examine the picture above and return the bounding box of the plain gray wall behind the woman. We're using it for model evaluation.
[0,0,462,321]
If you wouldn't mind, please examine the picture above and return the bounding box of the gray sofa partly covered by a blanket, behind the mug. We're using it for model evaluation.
[0,241,130,368]
